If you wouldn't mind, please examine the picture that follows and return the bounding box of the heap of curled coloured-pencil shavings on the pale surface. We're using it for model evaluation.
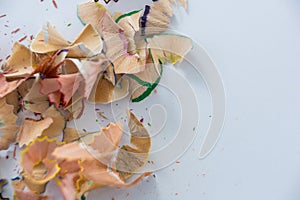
[0,0,192,200]
